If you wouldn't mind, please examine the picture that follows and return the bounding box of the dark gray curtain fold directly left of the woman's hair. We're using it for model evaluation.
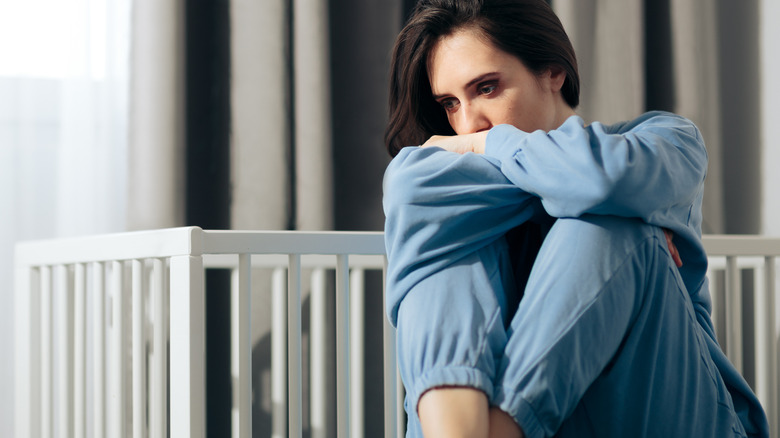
[330,0,396,230]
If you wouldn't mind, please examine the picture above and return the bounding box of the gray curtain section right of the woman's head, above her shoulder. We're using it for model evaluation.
[553,0,761,233]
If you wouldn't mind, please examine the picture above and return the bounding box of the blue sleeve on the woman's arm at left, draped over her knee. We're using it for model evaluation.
[383,147,542,325]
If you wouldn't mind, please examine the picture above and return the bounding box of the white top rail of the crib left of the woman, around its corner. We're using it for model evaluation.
[15,227,385,267]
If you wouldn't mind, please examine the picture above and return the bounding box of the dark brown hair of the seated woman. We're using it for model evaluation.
[385,0,580,156]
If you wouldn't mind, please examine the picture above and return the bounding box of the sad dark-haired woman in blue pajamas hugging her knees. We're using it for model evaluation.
[384,0,767,438]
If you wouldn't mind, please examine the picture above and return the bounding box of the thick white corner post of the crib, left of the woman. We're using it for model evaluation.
[169,255,206,438]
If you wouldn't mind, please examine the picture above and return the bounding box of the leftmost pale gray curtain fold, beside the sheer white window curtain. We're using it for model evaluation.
[127,0,185,230]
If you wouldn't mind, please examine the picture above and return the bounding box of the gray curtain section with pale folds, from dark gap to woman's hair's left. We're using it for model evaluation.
[230,0,394,234]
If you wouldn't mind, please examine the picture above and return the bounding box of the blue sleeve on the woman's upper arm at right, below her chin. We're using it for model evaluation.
[485,112,707,231]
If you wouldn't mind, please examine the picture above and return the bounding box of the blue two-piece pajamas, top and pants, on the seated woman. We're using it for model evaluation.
[384,113,767,437]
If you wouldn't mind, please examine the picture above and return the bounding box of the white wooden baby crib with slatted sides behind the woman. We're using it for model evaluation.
[15,227,780,438]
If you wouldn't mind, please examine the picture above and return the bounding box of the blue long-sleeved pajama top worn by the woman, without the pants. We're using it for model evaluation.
[384,112,768,435]
